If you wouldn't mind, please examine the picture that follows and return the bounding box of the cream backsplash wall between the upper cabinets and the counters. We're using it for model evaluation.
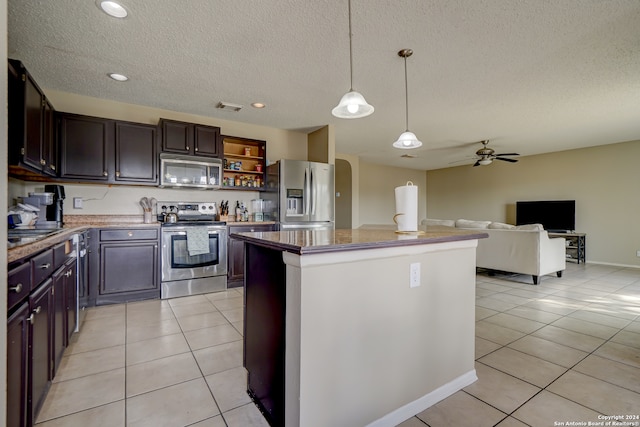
[7,178,260,216]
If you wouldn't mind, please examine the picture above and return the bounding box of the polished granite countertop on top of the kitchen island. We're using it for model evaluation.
[231,226,489,255]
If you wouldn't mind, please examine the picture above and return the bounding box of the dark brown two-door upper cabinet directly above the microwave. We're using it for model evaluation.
[160,119,222,158]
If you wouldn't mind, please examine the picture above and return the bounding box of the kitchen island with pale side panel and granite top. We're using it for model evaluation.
[231,227,487,427]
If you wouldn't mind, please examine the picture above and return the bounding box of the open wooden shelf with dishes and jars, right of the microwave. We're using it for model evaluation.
[222,136,267,191]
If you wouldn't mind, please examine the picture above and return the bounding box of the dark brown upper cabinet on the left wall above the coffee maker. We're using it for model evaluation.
[7,59,58,177]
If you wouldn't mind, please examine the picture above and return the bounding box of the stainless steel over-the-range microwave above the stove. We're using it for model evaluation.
[160,153,222,190]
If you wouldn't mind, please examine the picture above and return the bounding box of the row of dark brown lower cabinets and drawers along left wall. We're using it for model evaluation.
[6,242,77,427]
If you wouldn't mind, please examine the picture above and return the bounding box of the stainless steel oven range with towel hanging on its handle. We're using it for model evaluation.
[157,202,227,299]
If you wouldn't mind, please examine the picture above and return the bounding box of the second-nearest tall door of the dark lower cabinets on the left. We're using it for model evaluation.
[27,279,52,425]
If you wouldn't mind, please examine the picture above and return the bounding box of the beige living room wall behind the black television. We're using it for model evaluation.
[427,141,640,267]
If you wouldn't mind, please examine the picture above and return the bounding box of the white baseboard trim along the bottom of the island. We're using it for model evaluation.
[367,369,478,427]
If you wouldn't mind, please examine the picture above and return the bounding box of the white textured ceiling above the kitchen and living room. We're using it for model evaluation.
[8,0,640,169]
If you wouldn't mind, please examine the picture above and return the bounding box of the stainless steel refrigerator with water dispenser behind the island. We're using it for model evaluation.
[262,159,335,230]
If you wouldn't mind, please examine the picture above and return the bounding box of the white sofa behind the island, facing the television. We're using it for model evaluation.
[422,219,566,285]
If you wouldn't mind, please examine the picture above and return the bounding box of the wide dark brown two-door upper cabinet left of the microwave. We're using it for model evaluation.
[57,113,158,185]
